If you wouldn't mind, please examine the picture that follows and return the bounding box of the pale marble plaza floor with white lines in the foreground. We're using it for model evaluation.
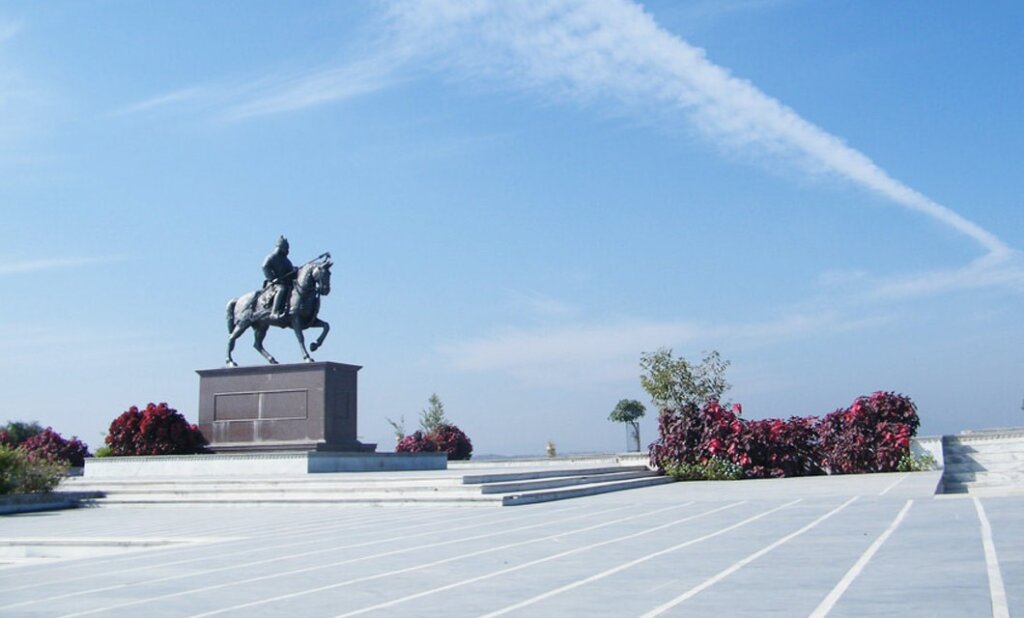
[0,472,1024,617]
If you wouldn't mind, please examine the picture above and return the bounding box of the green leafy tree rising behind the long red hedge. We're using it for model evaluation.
[640,348,730,412]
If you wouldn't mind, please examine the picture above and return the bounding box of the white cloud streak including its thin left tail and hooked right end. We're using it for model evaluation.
[108,0,1024,299]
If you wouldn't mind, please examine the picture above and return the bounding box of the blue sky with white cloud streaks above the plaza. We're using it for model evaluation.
[0,0,1024,454]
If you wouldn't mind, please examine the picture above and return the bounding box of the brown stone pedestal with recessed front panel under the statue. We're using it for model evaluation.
[197,362,376,452]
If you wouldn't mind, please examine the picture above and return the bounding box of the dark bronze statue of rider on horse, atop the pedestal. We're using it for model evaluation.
[227,236,334,367]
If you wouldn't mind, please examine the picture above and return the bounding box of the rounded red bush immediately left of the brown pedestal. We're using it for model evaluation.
[106,403,207,455]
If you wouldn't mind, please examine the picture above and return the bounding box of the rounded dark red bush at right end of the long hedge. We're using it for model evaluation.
[817,391,921,474]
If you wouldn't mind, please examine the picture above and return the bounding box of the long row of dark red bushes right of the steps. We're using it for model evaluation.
[650,392,920,478]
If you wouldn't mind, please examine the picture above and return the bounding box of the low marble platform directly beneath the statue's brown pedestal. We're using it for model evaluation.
[83,451,447,479]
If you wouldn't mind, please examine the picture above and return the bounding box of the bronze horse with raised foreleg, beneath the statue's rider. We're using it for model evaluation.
[227,254,334,367]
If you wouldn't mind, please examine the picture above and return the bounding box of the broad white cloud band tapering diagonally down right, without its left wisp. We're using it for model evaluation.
[389,0,1012,259]
